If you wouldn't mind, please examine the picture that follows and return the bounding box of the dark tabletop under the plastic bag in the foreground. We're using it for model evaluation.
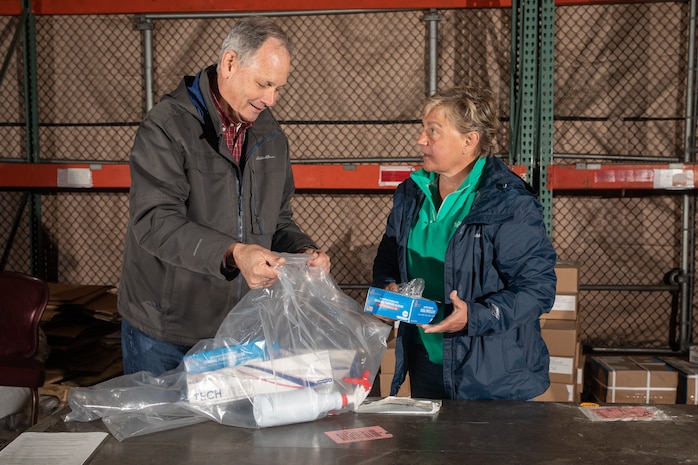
[23,401,698,465]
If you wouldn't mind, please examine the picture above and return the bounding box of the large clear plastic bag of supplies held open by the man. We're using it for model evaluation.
[64,254,390,440]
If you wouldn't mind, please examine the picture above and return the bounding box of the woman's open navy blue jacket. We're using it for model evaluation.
[372,157,556,400]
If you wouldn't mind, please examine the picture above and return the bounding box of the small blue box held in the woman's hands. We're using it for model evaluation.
[364,287,439,324]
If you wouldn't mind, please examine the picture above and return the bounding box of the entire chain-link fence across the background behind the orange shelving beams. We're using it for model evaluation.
[0,2,695,349]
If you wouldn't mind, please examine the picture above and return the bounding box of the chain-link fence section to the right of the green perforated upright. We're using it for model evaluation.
[553,2,698,349]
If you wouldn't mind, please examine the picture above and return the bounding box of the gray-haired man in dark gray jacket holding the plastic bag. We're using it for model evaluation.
[118,18,330,375]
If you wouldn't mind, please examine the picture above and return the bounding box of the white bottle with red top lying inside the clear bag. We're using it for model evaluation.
[252,388,348,428]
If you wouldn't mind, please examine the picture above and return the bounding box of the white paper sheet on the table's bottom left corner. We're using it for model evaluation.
[0,432,107,465]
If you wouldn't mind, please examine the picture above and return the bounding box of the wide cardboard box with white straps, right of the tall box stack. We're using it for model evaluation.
[587,356,678,404]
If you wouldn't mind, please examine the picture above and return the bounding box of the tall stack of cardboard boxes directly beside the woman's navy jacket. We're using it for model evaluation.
[535,262,584,402]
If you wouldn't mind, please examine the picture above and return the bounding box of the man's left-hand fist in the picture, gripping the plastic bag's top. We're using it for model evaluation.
[226,242,286,289]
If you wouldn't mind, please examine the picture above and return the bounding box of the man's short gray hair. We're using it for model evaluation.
[218,16,293,66]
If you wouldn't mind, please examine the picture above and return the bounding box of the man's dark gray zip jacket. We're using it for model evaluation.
[118,66,314,345]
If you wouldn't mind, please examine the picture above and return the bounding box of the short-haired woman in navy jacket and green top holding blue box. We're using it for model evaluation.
[372,86,556,400]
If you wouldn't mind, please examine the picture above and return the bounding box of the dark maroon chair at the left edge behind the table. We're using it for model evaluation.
[0,271,49,425]
